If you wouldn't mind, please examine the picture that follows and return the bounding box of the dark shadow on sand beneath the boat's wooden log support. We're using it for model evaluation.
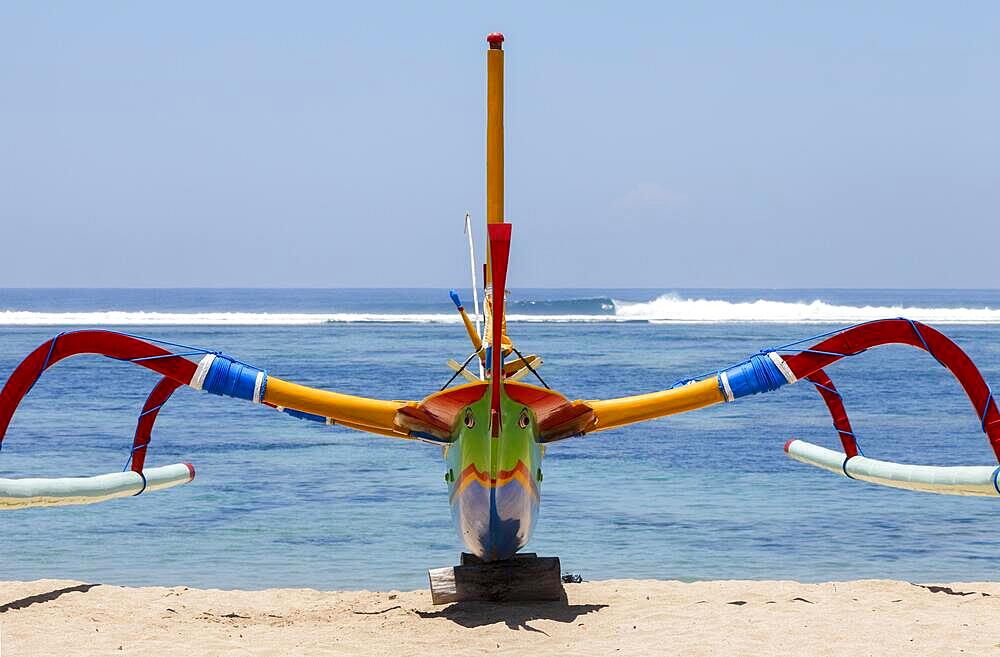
[416,598,608,634]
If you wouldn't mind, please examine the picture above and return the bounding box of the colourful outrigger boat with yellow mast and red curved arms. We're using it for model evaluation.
[0,34,1000,561]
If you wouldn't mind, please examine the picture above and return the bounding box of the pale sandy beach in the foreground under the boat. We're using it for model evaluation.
[0,580,1000,657]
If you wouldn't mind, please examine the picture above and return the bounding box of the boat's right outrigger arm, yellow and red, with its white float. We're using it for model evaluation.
[582,318,1000,497]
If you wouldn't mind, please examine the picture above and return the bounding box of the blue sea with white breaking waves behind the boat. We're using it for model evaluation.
[0,289,1000,589]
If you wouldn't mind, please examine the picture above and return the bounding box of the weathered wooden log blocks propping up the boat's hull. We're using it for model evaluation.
[427,552,566,605]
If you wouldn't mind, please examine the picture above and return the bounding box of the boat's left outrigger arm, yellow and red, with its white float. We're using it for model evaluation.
[0,330,426,509]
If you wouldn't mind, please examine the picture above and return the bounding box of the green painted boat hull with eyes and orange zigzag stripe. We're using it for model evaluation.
[445,387,544,561]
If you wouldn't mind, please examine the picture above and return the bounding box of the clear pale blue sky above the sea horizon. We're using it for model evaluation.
[0,1,1000,288]
